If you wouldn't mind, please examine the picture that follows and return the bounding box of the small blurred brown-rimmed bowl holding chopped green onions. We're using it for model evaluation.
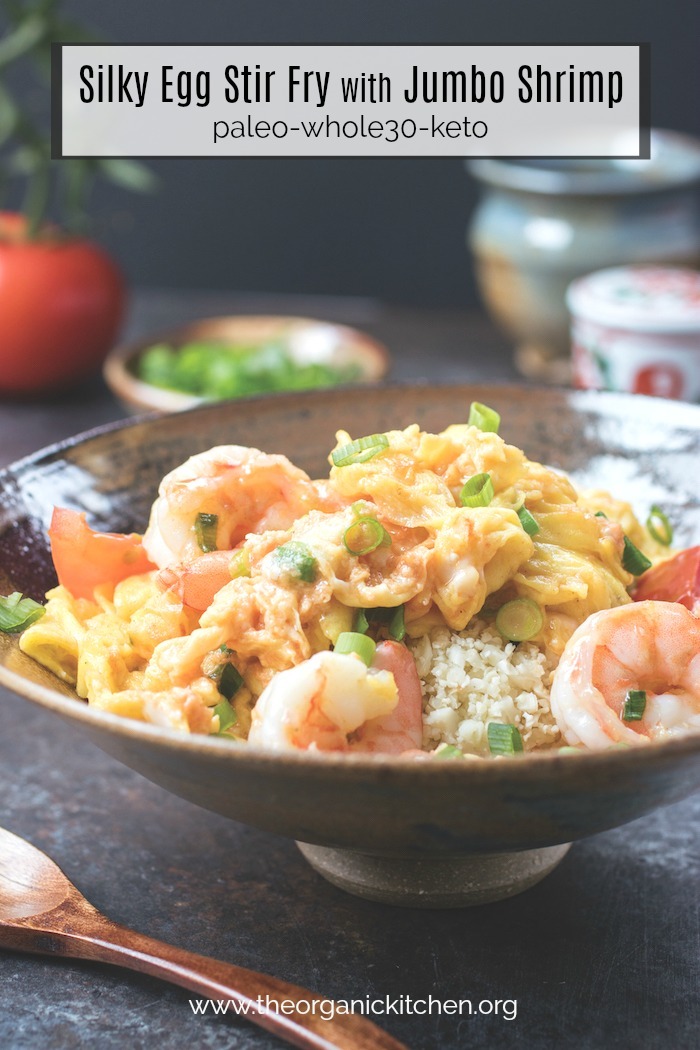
[103,315,390,413]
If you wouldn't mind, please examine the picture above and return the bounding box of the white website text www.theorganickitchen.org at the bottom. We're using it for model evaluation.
[190,995,517,1021]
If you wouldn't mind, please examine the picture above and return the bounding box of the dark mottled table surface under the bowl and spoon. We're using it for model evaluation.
[0,292,700,1050]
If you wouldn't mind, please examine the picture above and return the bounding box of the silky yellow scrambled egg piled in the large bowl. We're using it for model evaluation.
[21,425,646,738]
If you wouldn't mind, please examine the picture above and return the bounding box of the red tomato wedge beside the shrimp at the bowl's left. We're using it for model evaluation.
[48,507,155,599]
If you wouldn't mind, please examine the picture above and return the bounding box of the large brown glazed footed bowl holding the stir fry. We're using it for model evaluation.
[0,386,700,907]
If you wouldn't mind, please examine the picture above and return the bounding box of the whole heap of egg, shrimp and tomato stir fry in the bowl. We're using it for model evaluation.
[5,403,700,759]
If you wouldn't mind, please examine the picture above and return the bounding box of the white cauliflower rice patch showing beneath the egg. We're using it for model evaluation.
[407,620,560,756]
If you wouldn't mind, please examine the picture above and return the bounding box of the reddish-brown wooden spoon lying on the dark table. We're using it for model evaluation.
[0,828,407,1050]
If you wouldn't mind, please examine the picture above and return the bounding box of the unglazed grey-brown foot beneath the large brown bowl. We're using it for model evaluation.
[297,842,571,908]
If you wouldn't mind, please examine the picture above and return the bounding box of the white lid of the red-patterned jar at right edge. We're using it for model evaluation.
[567,266,700,332]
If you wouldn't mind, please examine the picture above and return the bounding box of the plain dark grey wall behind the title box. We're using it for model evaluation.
[16,0,700,306]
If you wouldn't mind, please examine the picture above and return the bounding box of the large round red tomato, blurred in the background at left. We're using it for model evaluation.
[0,212,125,394]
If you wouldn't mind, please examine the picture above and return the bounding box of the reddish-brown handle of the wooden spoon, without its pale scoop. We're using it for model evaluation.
[13,912,408,1050]
